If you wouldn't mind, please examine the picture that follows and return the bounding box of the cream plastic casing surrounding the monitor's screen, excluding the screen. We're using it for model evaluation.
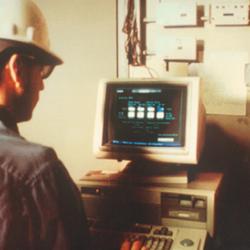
[93,77,205,164]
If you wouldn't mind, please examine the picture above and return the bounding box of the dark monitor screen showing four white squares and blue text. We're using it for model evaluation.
[103,83,187,147]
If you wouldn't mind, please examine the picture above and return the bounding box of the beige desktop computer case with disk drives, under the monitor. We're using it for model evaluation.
[77,173,222,237]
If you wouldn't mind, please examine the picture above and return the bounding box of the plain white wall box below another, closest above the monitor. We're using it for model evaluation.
[155,36,197,61]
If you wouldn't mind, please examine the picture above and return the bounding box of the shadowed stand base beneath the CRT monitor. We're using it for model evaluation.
[122,160,194,185]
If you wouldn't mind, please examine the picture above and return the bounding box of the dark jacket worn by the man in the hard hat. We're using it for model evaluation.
[0,110,90,250]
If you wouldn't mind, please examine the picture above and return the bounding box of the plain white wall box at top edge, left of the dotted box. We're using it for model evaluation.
[156,0,197,27]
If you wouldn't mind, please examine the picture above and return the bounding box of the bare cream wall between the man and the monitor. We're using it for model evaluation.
[20,0,119,179]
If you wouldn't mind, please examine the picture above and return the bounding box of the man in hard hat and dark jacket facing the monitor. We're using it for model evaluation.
[0,0,90,250]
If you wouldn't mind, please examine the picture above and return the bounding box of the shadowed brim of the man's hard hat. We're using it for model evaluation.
[0,38,63,66]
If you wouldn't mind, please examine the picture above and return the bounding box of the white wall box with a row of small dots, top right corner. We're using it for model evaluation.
[211,0,249,26]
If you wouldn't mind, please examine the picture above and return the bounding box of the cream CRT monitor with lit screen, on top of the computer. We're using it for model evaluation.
[94,77,205,164]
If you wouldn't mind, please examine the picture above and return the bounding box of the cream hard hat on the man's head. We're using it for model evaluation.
[0,0,62,65]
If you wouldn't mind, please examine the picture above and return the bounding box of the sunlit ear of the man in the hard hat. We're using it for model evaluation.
[6,54,24,95]
